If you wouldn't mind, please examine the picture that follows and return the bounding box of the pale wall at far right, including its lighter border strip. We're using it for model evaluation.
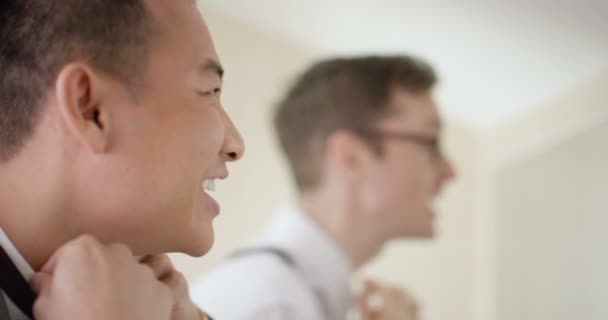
[474,70,608,320]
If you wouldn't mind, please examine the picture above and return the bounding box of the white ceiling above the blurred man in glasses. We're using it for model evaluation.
[202,0,608,130]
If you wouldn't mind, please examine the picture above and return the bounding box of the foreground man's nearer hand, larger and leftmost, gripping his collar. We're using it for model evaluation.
[31,236,175,320]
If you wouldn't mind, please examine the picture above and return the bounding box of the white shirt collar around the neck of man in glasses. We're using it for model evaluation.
[259,208,354,318]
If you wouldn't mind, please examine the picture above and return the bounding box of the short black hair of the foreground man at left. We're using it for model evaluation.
[0,0,152,163]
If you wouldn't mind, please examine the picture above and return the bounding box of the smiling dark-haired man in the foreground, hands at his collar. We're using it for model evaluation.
[0,0,243,320]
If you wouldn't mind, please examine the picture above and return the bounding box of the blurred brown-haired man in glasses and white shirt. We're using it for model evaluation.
[193,56,454,320]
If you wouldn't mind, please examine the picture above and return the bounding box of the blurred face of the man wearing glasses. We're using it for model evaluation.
[364,89,454,238]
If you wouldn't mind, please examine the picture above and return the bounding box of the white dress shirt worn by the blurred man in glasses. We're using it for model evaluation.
[191,209,354,320]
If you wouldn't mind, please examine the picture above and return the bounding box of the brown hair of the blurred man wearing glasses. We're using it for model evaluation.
[274,55,436,191]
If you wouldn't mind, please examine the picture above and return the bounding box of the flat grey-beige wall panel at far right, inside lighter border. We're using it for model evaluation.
[496,121,608,320]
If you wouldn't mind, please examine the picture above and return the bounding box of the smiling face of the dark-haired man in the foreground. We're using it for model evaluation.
[90,0,243,255]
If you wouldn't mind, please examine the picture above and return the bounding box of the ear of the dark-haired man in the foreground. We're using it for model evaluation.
[55,62,111,153]
